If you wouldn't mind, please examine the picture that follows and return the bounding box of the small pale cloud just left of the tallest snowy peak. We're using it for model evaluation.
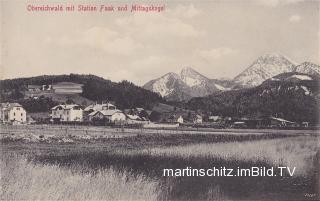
[196,47,235,61]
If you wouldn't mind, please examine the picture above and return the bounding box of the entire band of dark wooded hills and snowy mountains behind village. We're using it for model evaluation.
[0,54,320,124]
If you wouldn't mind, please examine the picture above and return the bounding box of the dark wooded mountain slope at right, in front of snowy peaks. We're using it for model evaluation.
[185,72,320,123]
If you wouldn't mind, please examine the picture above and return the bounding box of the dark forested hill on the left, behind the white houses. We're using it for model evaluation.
[0,74,165,110]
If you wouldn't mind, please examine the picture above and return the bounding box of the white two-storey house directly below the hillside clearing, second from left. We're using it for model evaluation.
[51,104,83,122]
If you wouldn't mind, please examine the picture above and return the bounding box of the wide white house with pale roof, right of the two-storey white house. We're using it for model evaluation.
[89,110,126,123]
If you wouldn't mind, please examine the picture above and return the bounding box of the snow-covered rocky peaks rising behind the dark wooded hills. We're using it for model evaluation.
[143,53,320,101]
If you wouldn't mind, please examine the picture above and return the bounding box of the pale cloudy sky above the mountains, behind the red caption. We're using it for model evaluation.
[0,0,320,86]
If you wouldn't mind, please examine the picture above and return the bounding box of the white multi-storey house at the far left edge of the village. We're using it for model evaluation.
[0,103,27,124]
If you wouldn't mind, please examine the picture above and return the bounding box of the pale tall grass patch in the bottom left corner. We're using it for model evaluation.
[0,155,157,200]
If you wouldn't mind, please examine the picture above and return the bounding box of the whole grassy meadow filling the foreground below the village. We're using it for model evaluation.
[0,127,320,200]
